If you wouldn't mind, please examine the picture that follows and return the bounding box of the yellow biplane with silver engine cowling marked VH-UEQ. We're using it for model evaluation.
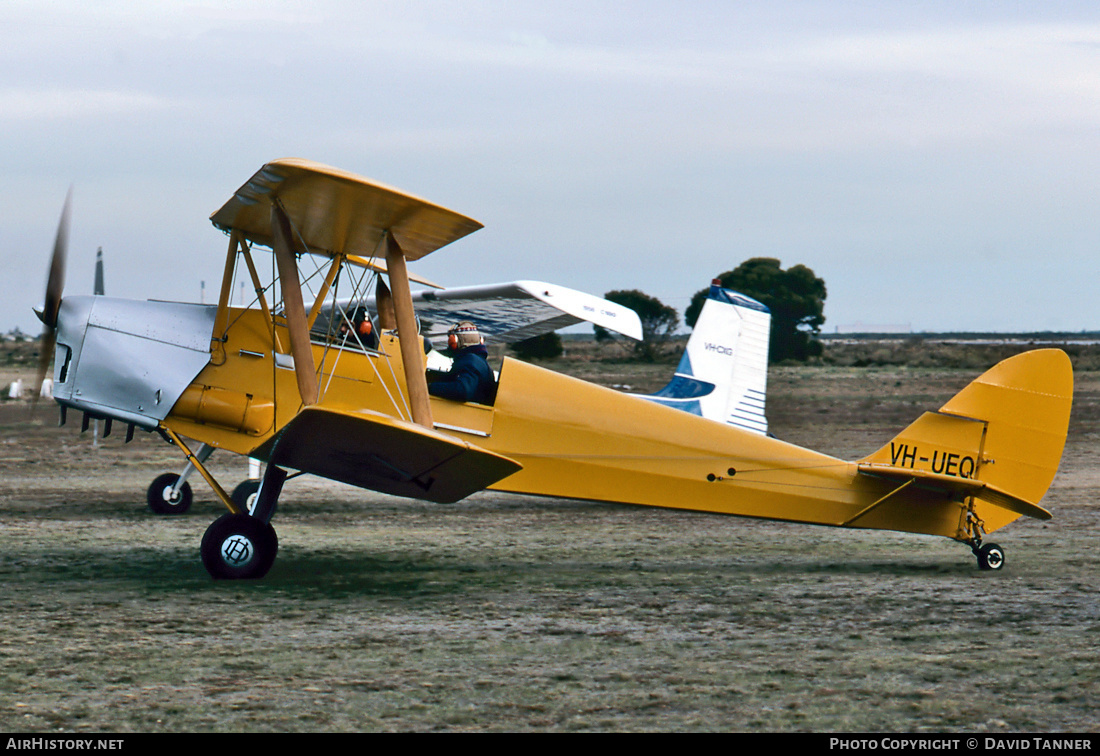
[40,160,1073,578]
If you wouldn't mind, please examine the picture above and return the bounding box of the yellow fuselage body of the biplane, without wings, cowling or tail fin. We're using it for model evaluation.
[165,309,1018,539]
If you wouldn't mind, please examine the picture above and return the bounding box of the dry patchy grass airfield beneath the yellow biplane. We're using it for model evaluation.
[0,343,1100,732]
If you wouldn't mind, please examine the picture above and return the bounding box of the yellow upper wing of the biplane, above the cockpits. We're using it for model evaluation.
[210,158,482,260]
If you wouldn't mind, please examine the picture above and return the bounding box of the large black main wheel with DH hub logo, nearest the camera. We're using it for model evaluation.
[201,514,278,580]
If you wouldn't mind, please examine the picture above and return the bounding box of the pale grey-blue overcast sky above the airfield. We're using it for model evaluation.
[0,0,1100,332]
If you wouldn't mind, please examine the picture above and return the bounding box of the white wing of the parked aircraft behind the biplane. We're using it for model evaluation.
[413,281,641,343]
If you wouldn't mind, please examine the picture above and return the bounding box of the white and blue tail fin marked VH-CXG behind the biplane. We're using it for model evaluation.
[645,281,771,434]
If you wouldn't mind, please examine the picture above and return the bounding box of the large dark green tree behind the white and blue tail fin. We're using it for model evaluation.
[684,258,825,362]
